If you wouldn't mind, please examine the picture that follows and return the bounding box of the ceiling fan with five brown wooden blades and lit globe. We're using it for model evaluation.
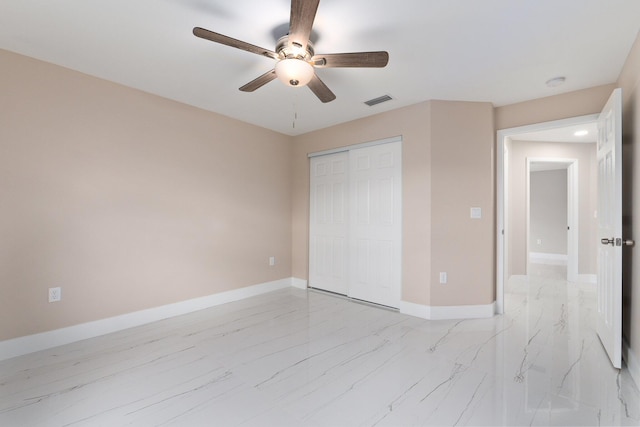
[193,0,389,102]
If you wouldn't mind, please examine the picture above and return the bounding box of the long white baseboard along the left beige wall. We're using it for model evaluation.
[0,278,296,360]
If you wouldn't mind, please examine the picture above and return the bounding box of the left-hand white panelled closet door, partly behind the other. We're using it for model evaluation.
[309,152,349,295]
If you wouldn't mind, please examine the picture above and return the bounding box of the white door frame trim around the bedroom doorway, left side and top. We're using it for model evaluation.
[496,114,598,314]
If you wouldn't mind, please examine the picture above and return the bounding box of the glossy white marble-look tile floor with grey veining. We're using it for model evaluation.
[0,267,640,427]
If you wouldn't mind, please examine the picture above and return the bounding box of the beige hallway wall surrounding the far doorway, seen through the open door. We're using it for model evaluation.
[507,141,598,275]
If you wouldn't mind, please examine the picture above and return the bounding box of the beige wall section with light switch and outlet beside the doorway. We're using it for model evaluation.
[427,101,495,306]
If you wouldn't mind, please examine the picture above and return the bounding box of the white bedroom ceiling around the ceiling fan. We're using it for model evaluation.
[0,0,640,135]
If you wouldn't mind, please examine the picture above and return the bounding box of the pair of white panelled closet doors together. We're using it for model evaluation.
[309,141,402,307]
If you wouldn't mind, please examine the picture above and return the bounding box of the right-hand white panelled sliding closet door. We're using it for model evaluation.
[349,142,402,308]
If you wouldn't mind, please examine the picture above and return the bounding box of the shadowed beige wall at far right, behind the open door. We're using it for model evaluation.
[618,34,640,384]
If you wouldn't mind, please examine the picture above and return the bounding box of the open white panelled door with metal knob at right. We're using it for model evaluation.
[597,89,623,368]
